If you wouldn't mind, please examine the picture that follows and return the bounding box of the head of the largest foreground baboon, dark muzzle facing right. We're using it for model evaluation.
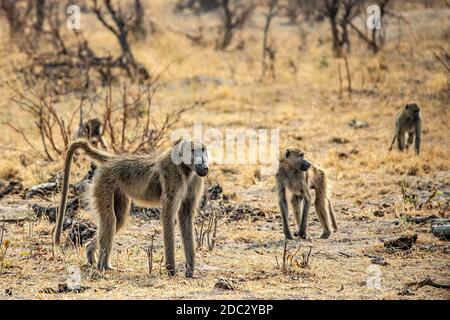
[172,140,209,177]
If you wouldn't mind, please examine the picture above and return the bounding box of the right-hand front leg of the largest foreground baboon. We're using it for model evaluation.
[178,198,195,278]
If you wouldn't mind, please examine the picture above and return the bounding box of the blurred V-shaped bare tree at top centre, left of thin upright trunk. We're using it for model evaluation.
[216,0,255,50]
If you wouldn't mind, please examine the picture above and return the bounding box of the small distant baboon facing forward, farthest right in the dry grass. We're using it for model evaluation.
[389,103,422,155]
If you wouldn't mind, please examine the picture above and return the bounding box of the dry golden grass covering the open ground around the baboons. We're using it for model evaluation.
[0,0,450,299]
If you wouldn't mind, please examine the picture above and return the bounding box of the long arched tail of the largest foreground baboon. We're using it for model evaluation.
[53,139,111,246]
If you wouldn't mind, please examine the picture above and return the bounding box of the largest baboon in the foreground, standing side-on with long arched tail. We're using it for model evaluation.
[54,139,209,277]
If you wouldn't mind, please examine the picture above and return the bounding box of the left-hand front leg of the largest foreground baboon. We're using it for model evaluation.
[161,195,180,276]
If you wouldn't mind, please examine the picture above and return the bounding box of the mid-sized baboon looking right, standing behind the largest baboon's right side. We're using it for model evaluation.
[275,148,338,240]
